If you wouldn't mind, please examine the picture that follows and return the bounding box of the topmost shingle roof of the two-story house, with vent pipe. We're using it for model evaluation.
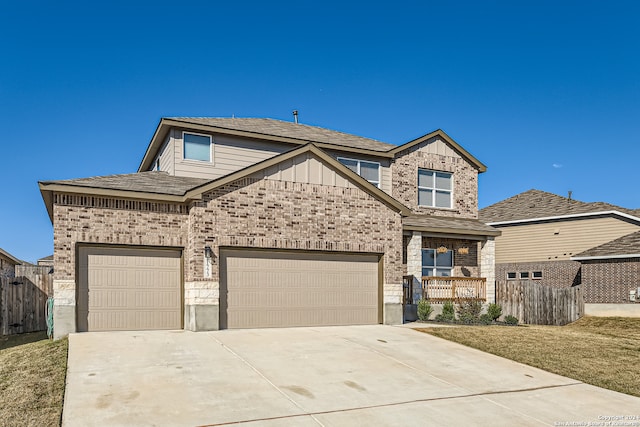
[167,117,396,152]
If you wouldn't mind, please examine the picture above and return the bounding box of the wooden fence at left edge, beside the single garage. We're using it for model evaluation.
[0,274,53,335]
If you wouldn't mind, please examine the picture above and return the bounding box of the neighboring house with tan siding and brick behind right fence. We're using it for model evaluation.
[479,190,640,315]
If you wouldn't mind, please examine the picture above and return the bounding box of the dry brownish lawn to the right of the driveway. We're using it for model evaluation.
[418,317,640,397]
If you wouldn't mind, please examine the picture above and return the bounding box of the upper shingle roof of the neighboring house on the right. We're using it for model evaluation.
[478,189,638,223]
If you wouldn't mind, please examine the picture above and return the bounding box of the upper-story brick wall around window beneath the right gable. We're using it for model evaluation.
[391,138,478,219]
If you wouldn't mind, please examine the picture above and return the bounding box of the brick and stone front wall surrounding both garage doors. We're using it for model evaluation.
[53,178,402,337]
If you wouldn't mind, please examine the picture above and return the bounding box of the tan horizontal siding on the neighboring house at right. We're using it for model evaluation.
[496,217,640,264]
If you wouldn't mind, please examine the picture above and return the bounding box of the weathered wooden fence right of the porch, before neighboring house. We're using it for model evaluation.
[496,280,584,326]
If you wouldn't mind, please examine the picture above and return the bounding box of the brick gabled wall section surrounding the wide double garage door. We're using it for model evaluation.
[187,178,402,294]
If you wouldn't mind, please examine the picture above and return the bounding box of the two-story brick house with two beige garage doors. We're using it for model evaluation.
[40,118,499,337]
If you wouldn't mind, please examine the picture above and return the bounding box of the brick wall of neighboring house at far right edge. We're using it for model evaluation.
[582,258,640,304]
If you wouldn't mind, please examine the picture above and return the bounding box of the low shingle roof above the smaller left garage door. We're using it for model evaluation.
[43,172,211,196]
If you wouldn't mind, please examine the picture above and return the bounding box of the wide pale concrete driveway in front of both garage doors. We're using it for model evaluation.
[63,325,640,427]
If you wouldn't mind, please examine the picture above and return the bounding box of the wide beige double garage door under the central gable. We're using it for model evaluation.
[220,249,381,329]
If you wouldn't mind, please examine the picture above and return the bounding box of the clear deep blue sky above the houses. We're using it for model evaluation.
[0,0,640,261]
